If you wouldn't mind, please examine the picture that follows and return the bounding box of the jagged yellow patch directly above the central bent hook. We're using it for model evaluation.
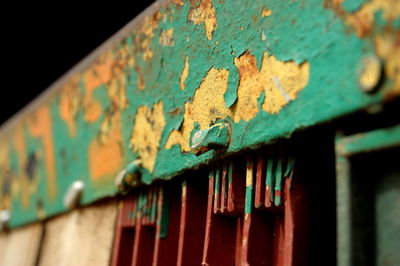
[165,68,230,152]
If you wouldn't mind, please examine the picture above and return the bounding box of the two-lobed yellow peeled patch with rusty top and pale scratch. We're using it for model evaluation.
[232,53,309,122]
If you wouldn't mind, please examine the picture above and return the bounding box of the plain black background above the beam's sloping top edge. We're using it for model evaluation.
[0,0,154,126]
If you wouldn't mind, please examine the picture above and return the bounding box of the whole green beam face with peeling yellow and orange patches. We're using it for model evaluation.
[0,0,400,226]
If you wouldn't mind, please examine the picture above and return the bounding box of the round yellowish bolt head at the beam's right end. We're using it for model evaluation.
[358,55,382,92]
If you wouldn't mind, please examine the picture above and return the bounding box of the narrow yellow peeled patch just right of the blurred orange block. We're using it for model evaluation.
[131,101,165,172]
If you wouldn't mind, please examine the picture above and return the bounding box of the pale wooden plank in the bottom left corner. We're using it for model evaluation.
[0,223,43,266]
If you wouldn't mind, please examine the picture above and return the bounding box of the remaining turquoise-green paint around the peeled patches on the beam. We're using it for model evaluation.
[0,0,399,226]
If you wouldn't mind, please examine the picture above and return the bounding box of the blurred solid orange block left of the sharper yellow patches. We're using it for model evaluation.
[88,115,123,179]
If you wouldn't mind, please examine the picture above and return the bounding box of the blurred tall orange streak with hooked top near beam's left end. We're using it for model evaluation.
[28,106,57,199]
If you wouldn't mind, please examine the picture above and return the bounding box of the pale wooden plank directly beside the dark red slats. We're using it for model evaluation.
[39,201,117,266]
